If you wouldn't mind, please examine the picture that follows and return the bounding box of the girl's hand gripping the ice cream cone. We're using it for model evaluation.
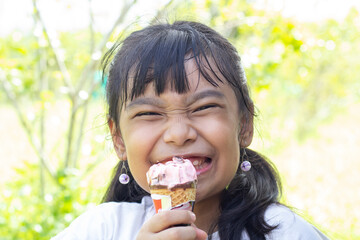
[136,210,207,240]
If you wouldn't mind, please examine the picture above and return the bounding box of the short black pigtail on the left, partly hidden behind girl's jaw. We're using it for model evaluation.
[102,161,149,202]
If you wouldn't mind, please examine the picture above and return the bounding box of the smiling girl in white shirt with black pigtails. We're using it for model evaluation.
[54,21,327,240]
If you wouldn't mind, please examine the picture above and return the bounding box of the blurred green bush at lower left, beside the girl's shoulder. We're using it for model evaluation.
[0,163,101,240]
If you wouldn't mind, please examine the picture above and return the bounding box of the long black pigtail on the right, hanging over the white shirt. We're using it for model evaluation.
[215,149,281,240]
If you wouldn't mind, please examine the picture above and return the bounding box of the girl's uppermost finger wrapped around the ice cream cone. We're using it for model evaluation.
[143,210,196,233]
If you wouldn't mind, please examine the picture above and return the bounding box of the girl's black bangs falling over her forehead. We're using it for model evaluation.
[121,23,222,103]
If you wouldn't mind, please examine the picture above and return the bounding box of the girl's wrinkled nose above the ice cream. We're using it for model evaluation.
[164,117,197,146]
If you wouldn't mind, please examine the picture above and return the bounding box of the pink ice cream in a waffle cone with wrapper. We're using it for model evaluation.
[146,157,197,212]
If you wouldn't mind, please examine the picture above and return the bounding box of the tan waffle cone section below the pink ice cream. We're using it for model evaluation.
[150,188,196,207]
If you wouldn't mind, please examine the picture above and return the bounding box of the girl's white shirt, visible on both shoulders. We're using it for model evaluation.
[51,196,328,240]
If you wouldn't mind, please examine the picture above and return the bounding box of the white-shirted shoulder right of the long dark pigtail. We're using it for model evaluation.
[265,204,328,240]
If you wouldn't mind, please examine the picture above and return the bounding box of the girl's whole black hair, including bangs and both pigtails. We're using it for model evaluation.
[103,21,280,240]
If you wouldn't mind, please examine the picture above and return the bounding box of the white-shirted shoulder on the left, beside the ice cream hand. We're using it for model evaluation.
[52,197,155,240]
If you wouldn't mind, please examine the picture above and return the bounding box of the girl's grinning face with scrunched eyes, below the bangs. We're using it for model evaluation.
[114,60,252,203]
